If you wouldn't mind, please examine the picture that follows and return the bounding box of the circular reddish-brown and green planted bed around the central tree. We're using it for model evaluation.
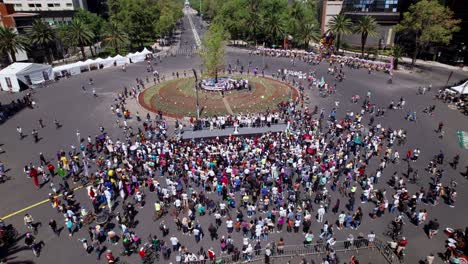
[138,76,298,118]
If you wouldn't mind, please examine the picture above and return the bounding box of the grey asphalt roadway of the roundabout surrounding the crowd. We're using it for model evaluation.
[0,8,468,264]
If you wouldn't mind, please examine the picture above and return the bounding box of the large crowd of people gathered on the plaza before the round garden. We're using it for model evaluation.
[1,44,466,263]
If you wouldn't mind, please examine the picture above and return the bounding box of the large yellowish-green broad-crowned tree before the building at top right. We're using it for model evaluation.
[396,0,460,65]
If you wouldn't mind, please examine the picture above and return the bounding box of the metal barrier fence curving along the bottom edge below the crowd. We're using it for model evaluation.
[178,239,404,264]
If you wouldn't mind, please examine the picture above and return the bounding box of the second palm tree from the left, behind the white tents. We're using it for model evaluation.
[27,19,56,64]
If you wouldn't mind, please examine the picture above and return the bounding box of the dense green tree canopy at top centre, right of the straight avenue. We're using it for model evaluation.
[191,0,320,48]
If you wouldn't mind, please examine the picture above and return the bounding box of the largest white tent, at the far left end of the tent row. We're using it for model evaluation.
[0,62,53,92]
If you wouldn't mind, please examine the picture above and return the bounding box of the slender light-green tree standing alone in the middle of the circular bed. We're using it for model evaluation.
[200,23,228,82]
